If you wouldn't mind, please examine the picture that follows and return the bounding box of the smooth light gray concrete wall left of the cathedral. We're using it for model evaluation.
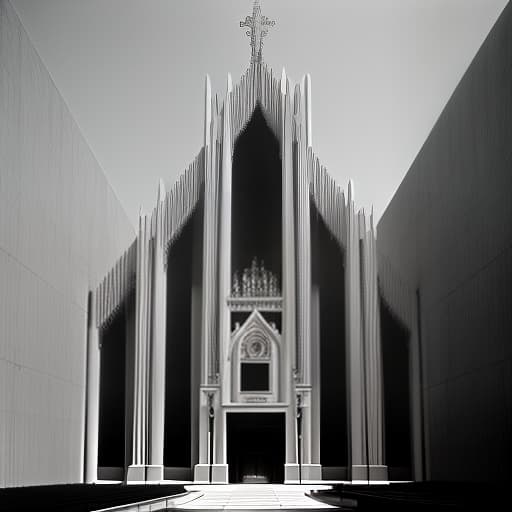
[0,0,134,486]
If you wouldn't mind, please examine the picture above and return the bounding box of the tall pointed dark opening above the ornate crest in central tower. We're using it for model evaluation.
[231,105,282,280]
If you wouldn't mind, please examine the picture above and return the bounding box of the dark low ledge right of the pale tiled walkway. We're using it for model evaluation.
[311,482,510,512]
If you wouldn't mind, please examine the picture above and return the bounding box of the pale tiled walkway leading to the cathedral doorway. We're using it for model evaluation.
[180,484,335,510]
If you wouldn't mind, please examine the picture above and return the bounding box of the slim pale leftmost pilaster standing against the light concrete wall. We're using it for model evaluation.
[85,292,100,484]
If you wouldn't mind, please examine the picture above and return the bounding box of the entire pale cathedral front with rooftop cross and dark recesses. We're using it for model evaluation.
[85,1,388,483]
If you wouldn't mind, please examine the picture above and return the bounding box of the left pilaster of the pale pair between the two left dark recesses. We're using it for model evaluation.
[127,212,152,482]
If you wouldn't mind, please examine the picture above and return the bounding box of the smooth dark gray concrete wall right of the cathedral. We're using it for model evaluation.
[378,3,512,480]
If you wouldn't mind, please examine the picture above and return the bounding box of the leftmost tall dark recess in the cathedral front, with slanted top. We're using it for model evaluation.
[98,307,126,479]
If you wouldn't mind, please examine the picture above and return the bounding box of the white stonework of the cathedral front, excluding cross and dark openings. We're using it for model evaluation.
[87,62,387,483]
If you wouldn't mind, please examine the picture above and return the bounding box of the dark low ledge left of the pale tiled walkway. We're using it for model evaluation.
[0,484,186,512]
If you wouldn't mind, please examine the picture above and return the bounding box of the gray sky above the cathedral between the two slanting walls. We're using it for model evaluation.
[11,0,507,224]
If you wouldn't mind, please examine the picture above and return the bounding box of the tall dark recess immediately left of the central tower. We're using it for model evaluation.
[164,208,202,468]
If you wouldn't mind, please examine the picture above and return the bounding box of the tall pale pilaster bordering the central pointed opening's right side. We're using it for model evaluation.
[281,69,299,482]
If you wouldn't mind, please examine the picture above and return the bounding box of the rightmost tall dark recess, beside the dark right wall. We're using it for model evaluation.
[380,298,412,480]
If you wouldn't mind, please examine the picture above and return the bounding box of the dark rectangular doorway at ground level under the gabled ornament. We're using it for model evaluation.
[227,412,286,483]
